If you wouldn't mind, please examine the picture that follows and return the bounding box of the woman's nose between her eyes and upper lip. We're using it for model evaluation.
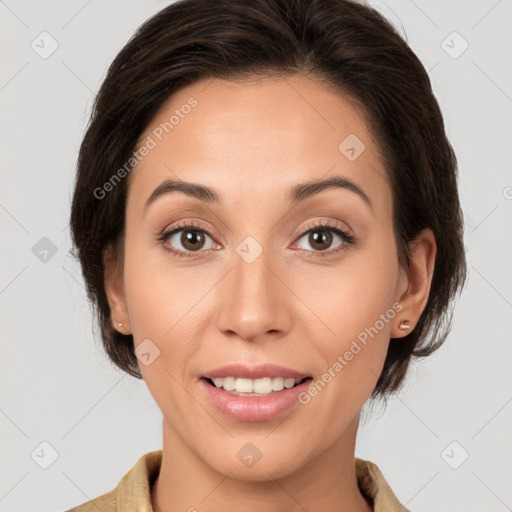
[217,242,293,342]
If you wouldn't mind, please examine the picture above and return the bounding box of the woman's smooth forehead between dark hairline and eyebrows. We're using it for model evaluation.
[128,76,390,214]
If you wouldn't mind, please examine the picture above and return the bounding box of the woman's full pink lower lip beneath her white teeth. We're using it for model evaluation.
[200,378,311,421]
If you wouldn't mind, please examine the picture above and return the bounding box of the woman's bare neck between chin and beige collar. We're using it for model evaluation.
[151,417,373,512]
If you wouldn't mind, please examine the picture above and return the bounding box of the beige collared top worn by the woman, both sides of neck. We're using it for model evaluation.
[66,450,411,512]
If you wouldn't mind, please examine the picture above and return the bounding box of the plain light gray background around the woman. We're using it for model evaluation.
[0,0,512,512]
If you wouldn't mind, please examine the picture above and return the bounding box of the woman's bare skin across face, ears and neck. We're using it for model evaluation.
[105,75,436,512]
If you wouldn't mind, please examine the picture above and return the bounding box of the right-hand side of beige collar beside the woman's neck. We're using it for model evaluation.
[356,458,412,512]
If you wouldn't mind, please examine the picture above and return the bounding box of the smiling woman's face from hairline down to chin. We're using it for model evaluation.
[107,75,428,479]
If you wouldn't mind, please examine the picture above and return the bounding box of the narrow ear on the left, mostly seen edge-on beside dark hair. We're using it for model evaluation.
[103,244,131,334]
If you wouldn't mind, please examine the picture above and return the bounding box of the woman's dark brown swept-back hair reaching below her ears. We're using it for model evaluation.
[70,0,466,398]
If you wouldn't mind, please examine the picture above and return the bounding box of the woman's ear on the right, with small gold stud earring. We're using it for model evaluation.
[391,228,437,338]
